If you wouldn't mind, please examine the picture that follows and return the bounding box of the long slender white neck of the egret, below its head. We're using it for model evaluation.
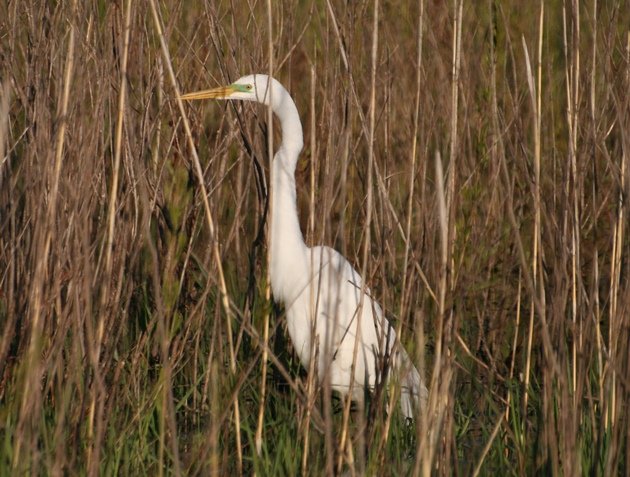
[271,88,308,304]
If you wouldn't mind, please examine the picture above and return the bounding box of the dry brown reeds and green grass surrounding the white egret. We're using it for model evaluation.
[0,0,630,475]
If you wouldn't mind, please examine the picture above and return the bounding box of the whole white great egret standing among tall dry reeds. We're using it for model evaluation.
[181,74,427,418]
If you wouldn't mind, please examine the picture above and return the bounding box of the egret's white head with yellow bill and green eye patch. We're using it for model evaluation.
[180,74,276,106]
